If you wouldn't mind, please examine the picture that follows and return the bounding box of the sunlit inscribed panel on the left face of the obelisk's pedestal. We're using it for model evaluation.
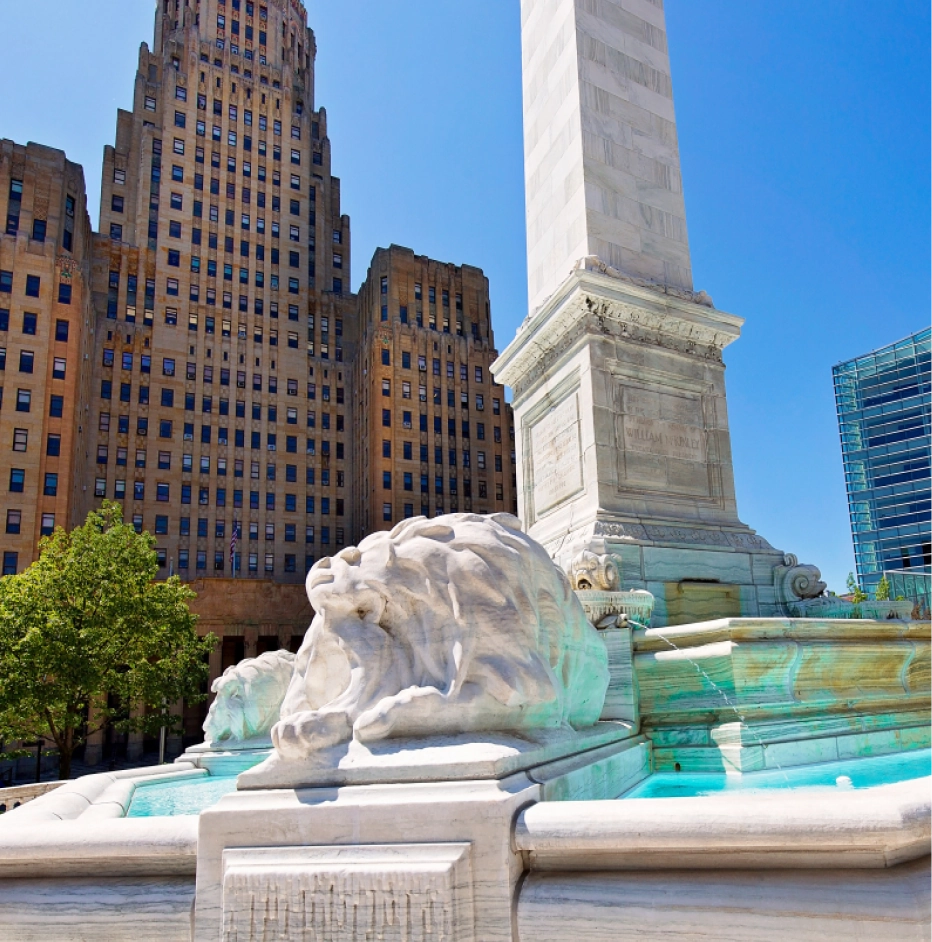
[530,393,583,517]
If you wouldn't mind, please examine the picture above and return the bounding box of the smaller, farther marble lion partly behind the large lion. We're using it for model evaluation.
[204,651,295,743]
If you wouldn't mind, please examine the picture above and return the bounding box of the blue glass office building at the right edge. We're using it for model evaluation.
[833,328,932,591]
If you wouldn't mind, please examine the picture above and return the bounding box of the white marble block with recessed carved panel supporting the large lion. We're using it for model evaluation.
[194,723,650,942]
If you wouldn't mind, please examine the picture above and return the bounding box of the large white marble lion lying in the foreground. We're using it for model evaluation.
[272,513,608,759]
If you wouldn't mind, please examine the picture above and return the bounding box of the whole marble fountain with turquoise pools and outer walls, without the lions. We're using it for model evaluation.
[0,619,932,942]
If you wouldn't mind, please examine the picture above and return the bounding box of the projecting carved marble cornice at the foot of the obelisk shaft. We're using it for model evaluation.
[492,263,744,397]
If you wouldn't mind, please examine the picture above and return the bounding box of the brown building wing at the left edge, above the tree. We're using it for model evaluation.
[0,140,94,575]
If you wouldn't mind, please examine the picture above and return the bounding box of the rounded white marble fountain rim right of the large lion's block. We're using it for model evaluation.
[515,776,932,871]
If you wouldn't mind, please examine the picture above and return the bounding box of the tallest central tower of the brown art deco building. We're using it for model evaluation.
[87,0,356,582]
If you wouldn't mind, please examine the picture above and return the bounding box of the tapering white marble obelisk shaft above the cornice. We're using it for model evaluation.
[521,0,693,311]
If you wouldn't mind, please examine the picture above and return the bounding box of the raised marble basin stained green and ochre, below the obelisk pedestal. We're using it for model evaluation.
[633,618,932,772]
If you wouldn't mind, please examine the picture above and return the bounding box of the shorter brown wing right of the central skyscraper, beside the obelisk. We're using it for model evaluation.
[354,245,517,535]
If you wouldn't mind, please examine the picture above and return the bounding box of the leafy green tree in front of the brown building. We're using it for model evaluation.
[0,502,216,778]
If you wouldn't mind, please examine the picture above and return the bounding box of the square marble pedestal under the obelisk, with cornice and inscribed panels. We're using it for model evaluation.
[493,258,784,624]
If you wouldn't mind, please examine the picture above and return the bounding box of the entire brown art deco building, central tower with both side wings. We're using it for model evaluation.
[0,0,516,754]
